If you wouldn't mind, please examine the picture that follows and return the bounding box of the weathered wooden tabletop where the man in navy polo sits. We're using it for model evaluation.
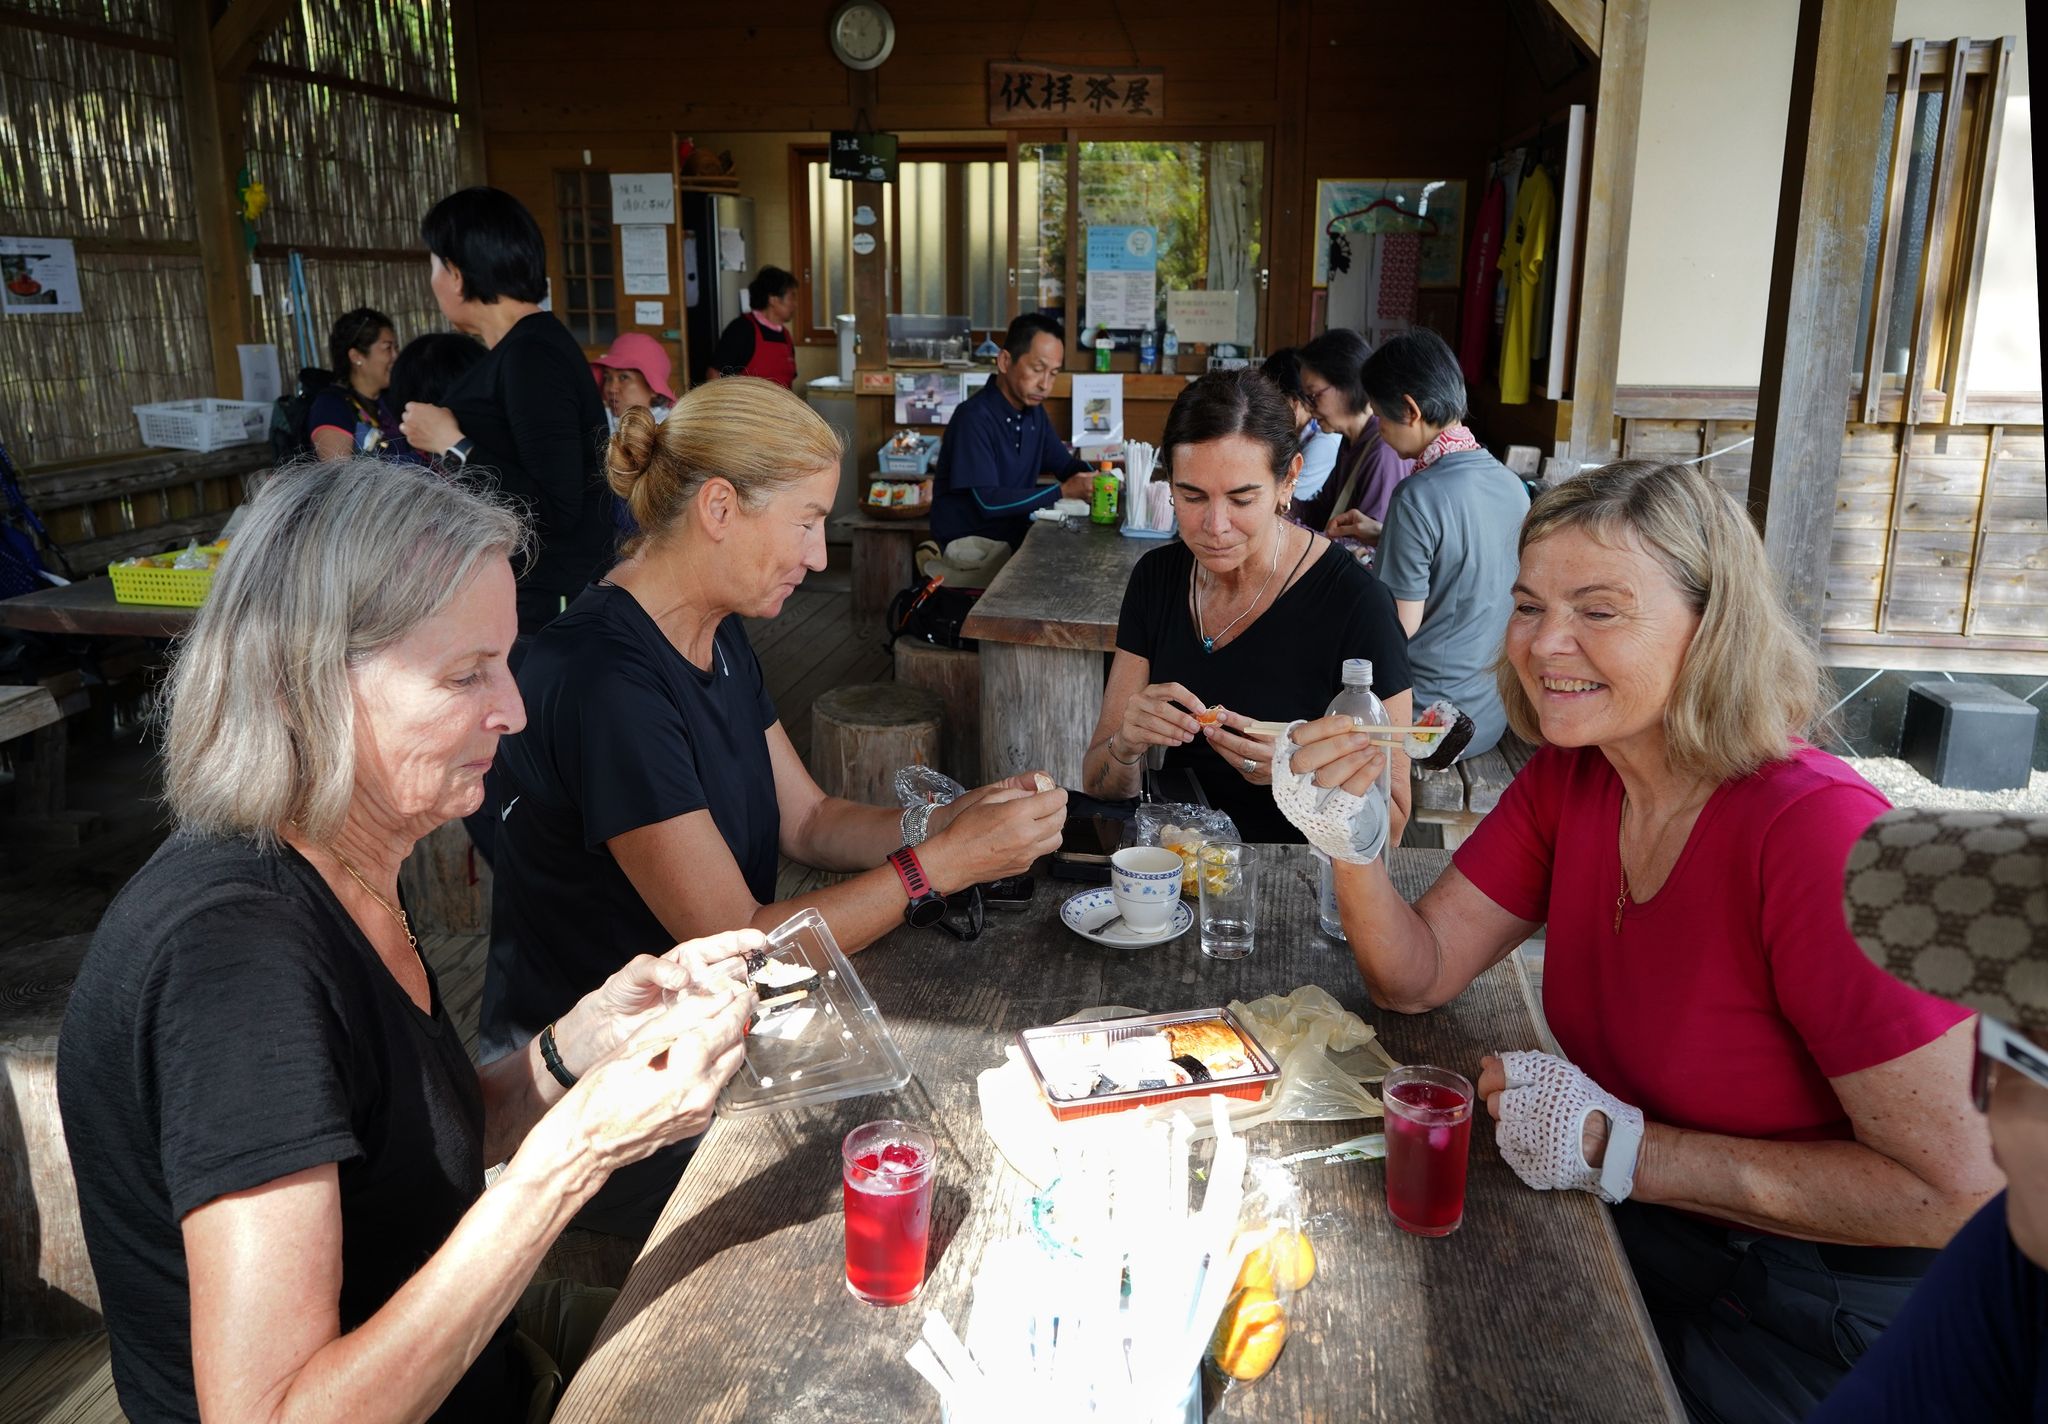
[961,522,1159,654]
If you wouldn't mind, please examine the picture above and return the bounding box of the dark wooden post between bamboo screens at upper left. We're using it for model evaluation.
[172,0,252,395]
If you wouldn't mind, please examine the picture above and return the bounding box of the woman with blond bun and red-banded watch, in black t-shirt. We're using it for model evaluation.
[481,377,1067,1238]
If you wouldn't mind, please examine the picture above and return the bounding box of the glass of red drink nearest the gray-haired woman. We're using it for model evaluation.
[840,1121,936,1305]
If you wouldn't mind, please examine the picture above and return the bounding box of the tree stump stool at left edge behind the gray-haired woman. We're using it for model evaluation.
[0,934,104,1336]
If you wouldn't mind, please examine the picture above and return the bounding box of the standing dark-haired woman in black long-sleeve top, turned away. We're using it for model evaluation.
[403,189,614,635]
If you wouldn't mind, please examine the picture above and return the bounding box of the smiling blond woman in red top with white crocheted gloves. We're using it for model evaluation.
[1292,461,1999,1422]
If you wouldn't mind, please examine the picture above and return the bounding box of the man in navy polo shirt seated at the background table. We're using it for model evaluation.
[932,311,1092,547]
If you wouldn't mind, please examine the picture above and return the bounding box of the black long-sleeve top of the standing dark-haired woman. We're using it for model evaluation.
[449,311,614,633]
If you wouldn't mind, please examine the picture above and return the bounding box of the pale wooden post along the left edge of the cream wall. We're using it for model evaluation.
[1567,0,1651,465]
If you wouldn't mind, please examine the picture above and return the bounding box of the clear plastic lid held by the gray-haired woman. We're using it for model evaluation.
[719,910,909,1117]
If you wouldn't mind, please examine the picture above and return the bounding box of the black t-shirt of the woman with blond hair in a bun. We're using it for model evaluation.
[481,584,782,1061]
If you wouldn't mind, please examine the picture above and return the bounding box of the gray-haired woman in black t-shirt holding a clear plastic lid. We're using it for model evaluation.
[57,461,764,1420]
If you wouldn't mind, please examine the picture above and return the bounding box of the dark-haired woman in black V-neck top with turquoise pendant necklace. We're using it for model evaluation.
[1081,371,1411,844]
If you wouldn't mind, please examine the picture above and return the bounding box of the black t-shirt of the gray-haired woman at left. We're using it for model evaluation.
[57,832,524,1422]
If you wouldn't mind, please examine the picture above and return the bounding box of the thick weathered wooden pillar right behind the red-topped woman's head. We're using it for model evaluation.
[1749,0,1907,631]
